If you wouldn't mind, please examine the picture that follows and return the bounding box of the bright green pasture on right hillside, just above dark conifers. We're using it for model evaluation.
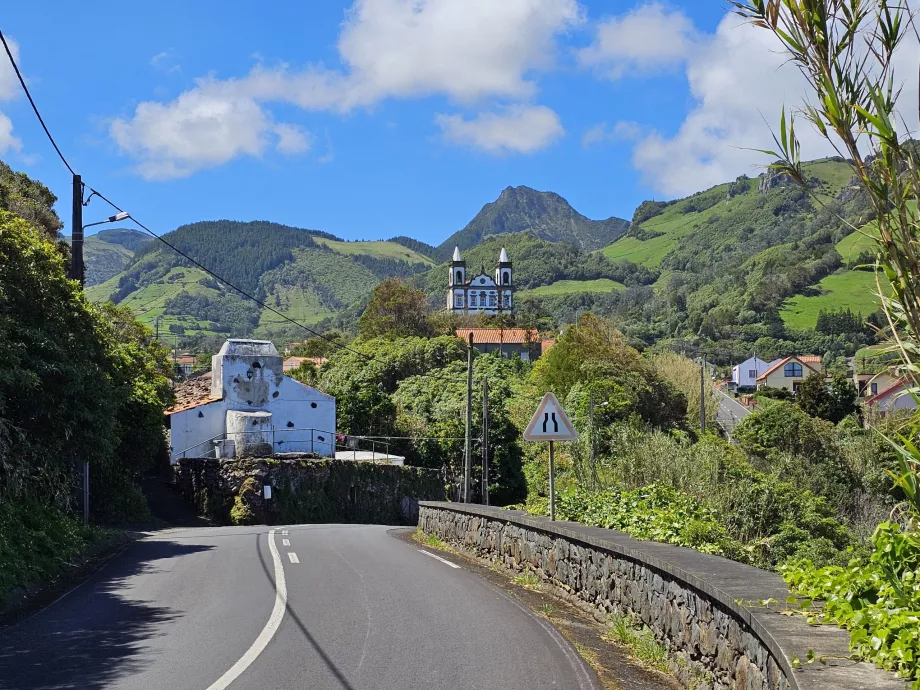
[780,271,880,329]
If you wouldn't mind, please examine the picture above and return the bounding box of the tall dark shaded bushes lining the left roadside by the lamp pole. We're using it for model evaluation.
[0,169,171,608]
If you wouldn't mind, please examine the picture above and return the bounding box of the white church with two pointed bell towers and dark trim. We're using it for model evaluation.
[447,247,514,316]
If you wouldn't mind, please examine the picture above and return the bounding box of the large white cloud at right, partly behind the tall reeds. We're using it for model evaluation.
[616,10,920,196]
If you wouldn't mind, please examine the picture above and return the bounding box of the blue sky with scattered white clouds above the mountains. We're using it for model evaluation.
[0,0,840,244]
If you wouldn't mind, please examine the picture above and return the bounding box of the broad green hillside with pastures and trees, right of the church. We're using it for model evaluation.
[540,158,879,360]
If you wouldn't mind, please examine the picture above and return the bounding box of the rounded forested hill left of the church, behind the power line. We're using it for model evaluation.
[87,220,433,339]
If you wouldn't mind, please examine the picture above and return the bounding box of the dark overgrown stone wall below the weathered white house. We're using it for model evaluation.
[174,455,444,525]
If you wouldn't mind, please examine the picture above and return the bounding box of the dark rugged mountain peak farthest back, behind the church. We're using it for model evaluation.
[438,187,629,258]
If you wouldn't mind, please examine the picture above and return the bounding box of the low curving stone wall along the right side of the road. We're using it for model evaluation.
[419,502,905,690]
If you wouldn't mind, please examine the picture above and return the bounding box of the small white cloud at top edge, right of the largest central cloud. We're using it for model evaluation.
[578,2,698,79]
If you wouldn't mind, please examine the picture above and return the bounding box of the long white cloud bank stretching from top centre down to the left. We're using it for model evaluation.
[110,0,581,178]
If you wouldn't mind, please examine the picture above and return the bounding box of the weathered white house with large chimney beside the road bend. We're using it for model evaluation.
[166,340,335,464]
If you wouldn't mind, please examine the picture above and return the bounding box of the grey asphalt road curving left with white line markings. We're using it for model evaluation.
[0,525,598,690]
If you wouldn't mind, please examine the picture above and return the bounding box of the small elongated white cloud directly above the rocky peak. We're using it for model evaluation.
[437,105,565,154]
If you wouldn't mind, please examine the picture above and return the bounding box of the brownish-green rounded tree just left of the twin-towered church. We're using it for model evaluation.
[358,278,432,338]
